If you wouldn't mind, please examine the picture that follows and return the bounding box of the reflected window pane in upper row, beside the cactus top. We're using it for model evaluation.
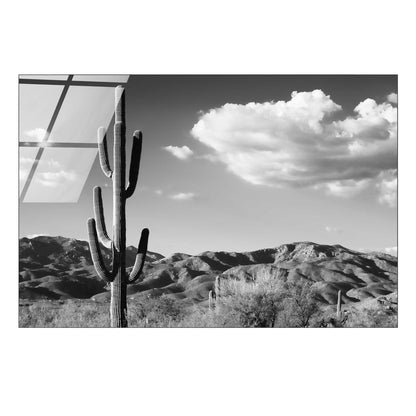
[49,86,115,143]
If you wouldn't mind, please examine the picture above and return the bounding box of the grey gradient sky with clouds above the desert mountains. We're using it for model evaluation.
[19,75,397,255]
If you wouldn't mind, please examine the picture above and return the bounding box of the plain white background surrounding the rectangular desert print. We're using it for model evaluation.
[0,0,416,416]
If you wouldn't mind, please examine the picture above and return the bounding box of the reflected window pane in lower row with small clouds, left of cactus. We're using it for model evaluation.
[24,148,98,202]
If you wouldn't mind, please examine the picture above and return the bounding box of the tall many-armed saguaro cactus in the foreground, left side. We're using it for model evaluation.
[87,86,149,328]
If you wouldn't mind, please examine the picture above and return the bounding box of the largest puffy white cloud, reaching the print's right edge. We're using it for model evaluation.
[191,90,397,208]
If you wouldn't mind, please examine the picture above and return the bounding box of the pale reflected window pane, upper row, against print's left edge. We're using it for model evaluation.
[19,84,63,142]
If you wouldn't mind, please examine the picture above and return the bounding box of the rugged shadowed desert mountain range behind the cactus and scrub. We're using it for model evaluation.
[19,236,397,305]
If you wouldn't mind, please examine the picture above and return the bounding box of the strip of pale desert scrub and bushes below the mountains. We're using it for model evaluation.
[19,276,397,328]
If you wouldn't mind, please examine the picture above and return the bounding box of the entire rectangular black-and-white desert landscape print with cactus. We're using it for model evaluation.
[19,74,398,328]
